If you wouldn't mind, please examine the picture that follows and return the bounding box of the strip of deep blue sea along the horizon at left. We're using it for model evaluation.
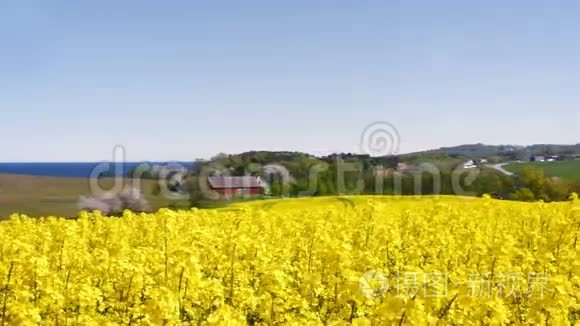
[0,162,195,178]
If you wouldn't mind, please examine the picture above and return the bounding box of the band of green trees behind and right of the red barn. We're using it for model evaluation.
[188,152,577,207]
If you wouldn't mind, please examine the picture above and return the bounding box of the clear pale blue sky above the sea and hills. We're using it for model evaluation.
[0,0,580,161]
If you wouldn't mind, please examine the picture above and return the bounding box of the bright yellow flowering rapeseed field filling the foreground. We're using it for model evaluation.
[0,196,580,325]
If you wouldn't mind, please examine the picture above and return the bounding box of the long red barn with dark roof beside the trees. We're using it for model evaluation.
[207,176,266,198]
